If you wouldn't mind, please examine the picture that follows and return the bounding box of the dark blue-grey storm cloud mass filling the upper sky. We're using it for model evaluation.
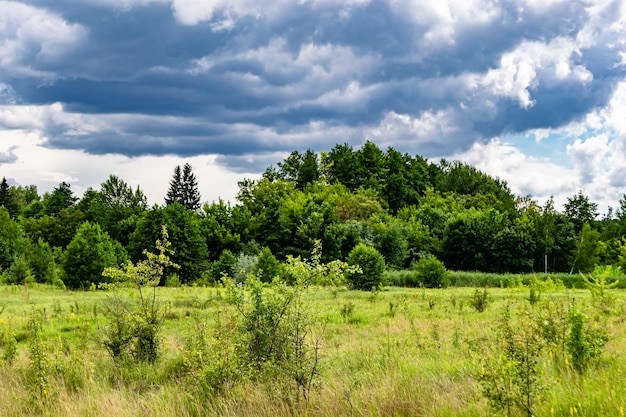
[0,0,625,169]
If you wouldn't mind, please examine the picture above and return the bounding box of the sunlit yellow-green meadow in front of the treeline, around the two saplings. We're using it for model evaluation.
[0,283,626,417]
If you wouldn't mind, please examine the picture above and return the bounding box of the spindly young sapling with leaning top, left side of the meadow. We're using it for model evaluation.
[102,225,179,362]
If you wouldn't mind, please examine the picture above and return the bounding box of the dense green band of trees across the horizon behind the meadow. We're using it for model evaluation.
[0,142,626,288]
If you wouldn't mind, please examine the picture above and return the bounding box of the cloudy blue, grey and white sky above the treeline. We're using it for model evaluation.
[0,0,626,212]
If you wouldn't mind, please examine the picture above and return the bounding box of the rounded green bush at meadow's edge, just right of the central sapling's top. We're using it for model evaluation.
[346,243,386,291]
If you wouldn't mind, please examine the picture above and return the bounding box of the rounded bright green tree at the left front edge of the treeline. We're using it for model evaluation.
[62,222,125,289]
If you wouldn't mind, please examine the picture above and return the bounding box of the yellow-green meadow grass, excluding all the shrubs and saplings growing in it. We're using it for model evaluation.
[0,282,626,416]
